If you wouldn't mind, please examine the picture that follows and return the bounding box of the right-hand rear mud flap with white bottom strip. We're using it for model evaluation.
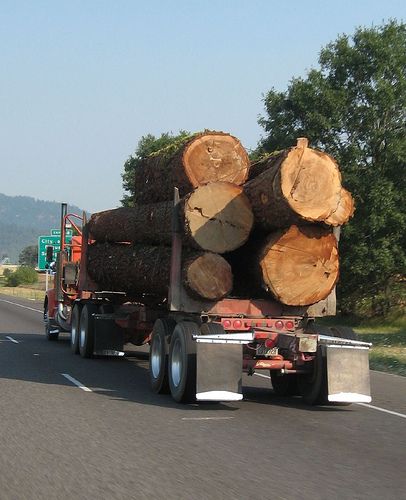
[326,345,371,403]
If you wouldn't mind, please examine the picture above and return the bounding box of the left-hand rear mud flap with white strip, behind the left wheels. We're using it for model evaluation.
[196,337,242,401]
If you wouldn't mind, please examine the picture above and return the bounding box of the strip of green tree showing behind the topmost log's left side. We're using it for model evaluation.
[121,130,189,207]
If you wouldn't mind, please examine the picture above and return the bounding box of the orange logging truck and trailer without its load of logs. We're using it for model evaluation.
[44,201,371,404]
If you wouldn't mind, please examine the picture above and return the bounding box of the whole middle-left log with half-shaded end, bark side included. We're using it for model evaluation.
[88,182,253,253]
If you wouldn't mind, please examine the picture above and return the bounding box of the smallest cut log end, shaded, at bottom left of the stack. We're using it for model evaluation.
[183,252,233,300]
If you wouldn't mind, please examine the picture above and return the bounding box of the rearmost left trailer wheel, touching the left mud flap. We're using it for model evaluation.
[168,321,199,403]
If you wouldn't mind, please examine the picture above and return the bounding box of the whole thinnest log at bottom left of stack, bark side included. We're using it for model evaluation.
[87,243,233,302]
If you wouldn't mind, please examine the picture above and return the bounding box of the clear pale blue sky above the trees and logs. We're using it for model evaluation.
[0,0,406,212]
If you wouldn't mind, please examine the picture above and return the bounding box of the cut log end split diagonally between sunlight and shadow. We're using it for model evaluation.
[184,182,254,253]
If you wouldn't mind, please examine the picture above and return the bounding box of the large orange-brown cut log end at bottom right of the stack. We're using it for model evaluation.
[259,226,339,306]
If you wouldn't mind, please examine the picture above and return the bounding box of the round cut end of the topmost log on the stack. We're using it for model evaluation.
[183,132,250,187]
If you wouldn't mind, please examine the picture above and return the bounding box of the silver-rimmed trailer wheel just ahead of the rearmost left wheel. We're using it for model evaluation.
[149,319,176,394]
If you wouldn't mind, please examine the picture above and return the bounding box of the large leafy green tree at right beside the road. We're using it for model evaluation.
[256,20,406,311]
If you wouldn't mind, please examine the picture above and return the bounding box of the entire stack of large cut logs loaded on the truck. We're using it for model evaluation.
[88,131,354,306]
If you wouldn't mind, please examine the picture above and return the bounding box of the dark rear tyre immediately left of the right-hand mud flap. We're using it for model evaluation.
[297,347,328,405]
